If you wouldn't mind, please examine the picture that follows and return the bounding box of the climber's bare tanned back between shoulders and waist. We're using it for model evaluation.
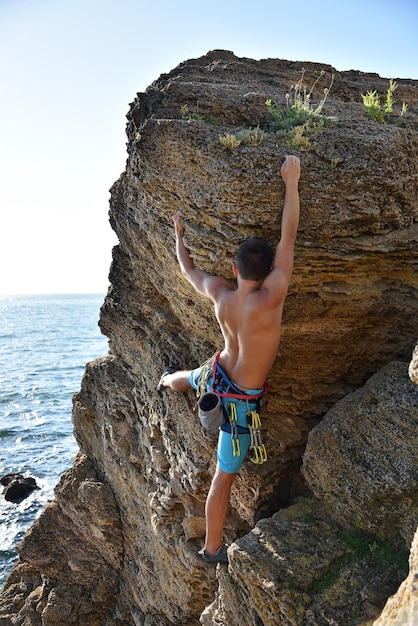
[215,288,287,389]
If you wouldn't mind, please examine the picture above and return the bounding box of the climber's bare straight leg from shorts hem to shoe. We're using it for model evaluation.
[205,466,236,554]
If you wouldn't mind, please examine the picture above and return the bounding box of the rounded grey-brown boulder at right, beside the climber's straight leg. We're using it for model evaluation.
[302,363,418,546]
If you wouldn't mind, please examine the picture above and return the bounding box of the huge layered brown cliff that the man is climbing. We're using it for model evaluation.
[0,51,418,626]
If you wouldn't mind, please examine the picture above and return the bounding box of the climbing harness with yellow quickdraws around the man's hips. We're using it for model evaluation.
[197,352,267,465]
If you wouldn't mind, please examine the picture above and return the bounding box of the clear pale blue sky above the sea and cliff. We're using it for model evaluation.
[0,0,418,294]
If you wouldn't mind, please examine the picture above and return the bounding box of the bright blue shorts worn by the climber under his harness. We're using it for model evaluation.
[189,364,263,474]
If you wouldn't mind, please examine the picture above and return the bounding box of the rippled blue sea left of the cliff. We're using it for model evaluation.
[0,294,108,587]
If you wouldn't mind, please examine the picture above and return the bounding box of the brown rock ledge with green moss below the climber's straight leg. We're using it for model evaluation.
[201,499,407,626]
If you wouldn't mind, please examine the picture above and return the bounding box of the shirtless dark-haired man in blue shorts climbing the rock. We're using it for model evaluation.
[157,156,300,563]
